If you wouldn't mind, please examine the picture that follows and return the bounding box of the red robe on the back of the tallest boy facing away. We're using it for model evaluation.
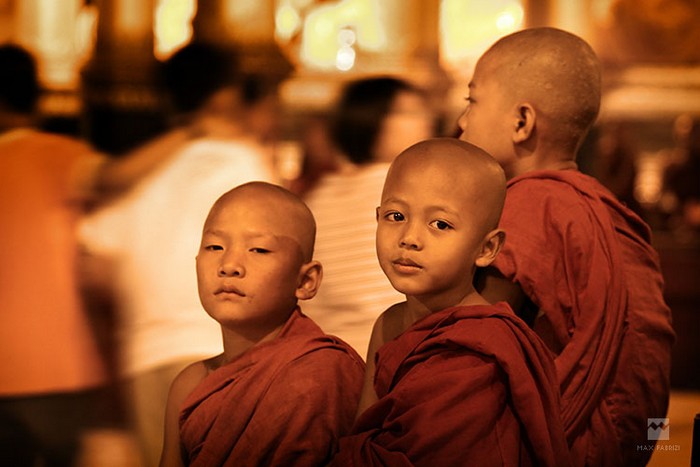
[494,171,674,466]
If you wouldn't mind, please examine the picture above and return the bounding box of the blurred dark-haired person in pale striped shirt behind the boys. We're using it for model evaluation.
[303,76,435,357]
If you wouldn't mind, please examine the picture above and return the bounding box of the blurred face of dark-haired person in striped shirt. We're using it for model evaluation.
[374,91,433,162]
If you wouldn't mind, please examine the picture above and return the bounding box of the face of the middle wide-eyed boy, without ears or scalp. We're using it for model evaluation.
[377,161,484,310]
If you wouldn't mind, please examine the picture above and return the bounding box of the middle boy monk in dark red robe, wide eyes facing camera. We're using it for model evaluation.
[334,138,569,466]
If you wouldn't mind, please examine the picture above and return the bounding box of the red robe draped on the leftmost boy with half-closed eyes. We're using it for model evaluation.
[180,309,364,467]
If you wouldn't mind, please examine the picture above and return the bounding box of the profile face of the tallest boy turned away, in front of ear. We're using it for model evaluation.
[459,59,516,174]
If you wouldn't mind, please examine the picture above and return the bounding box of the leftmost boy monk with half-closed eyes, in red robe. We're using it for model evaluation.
[161,182,364,466]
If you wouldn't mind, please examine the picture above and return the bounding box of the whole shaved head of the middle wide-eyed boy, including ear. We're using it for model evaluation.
[377,138,505,311]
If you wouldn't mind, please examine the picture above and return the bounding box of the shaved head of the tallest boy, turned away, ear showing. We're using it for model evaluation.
[459,28,600,178]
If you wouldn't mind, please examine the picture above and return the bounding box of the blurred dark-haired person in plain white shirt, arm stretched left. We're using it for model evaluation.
[81,43,284,466]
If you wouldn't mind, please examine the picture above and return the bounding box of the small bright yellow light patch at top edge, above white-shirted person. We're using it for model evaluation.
[153,0,197,60]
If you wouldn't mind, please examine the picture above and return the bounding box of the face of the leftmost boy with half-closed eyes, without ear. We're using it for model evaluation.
[197,193,304,331]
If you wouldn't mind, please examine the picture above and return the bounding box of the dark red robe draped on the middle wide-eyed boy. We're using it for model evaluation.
[333,303,569,467]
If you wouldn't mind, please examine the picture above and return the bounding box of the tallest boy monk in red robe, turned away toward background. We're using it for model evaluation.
[459,28,674,466]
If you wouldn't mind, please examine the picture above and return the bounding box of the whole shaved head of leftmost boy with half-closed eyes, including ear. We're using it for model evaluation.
[197,183,321,344]
